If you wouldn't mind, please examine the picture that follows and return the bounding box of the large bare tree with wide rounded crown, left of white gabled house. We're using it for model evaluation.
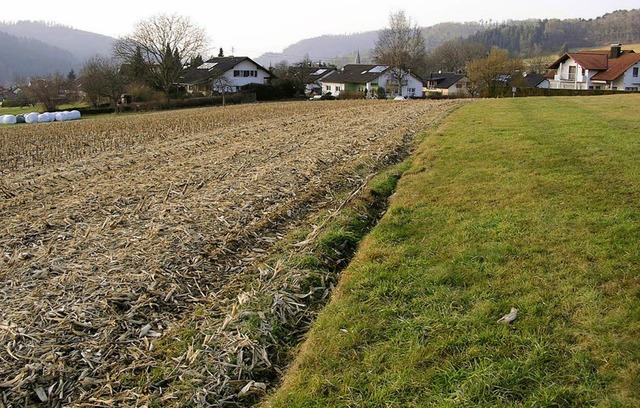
[113,14,208,97]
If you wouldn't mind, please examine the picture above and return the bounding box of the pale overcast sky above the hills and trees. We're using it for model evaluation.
[0,0,640,58]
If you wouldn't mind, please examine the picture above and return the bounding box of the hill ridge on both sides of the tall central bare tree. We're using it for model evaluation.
[256,9,640,67]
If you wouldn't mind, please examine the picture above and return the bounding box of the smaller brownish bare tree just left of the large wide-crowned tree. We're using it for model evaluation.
[80,56,127,113]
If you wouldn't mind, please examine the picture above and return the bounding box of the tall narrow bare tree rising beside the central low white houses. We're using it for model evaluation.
[373,11,427,91]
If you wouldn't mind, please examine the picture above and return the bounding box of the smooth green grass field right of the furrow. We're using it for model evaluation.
[263,95,640,407]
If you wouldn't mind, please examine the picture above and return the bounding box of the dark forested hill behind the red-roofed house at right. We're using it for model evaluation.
[467,9,640,56]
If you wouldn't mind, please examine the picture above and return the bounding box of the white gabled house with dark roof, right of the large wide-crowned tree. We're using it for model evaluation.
[178,57,273,94]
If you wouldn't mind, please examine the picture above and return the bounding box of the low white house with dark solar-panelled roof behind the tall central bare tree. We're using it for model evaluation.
[321,64,424,98]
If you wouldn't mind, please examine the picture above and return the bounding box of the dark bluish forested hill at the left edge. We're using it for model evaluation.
[0,31,80,84]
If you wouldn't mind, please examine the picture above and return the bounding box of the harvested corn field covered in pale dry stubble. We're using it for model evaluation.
[0,101,459,407]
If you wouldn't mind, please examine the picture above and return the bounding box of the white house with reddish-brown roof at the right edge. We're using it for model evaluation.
[546,44,640,91]
